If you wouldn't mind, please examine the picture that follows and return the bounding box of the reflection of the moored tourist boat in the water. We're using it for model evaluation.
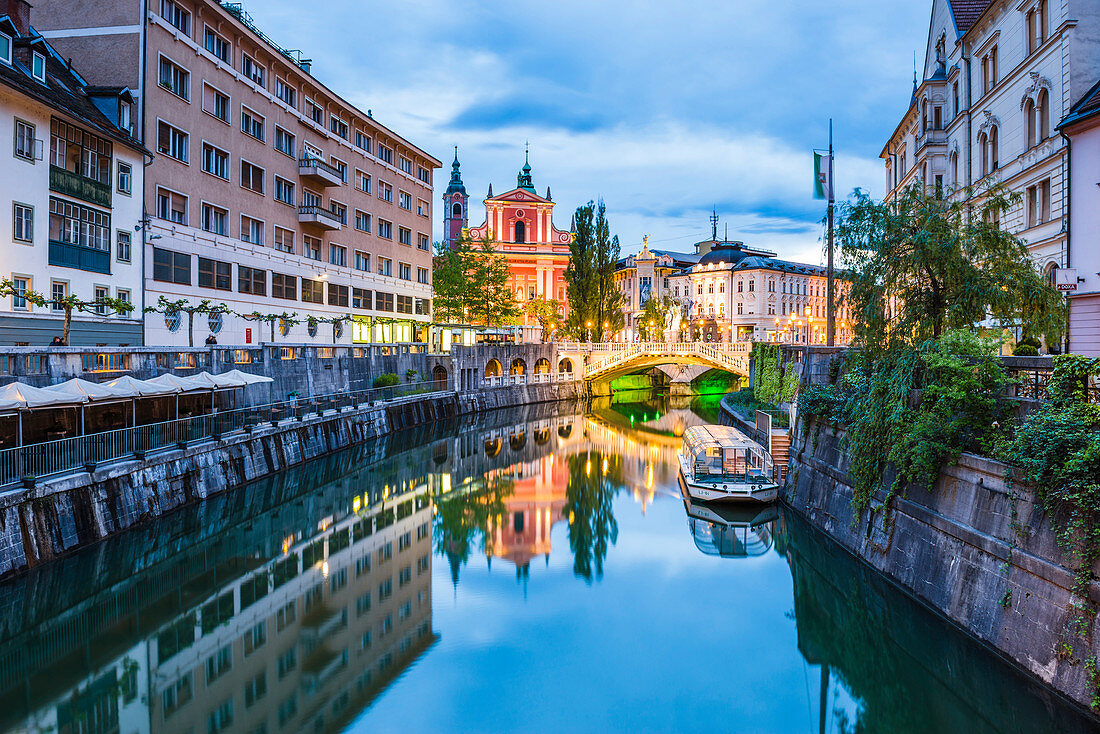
[683,494,779,558]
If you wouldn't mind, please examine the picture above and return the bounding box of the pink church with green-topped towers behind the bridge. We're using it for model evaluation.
[443,151,573,338]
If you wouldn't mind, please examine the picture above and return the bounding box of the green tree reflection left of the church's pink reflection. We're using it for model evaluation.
[435,474,513,585]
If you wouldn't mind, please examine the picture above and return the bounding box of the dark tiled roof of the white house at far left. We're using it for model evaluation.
[0,15,145,152]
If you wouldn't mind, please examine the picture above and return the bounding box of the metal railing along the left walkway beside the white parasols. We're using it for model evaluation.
[0,380,450,486]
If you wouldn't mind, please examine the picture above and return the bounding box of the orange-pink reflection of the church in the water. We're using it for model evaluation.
[485,453,569,572]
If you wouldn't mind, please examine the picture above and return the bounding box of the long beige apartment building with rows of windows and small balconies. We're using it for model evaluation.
[35,0,441,344]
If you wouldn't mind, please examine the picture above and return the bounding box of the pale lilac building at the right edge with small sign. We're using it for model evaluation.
[1057,83,1100,357]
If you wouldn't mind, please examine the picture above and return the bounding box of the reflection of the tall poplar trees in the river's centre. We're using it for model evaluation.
[562,451,623,583]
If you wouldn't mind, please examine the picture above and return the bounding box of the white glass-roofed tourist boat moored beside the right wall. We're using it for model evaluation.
[679,426,779,502]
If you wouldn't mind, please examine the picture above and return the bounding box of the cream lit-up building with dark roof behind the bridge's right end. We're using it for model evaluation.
[669,242,853,344]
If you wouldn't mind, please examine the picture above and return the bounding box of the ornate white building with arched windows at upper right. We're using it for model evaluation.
[880,0,1100,281]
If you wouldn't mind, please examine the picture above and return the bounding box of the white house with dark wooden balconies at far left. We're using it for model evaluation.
[0,0,145,346]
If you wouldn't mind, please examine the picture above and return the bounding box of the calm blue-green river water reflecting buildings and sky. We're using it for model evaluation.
[0,394,1095,734]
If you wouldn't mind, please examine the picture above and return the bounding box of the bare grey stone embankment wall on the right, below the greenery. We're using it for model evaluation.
[783,424,1100,706]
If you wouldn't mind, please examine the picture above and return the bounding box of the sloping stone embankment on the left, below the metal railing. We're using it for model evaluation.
[0,382,583,578]
